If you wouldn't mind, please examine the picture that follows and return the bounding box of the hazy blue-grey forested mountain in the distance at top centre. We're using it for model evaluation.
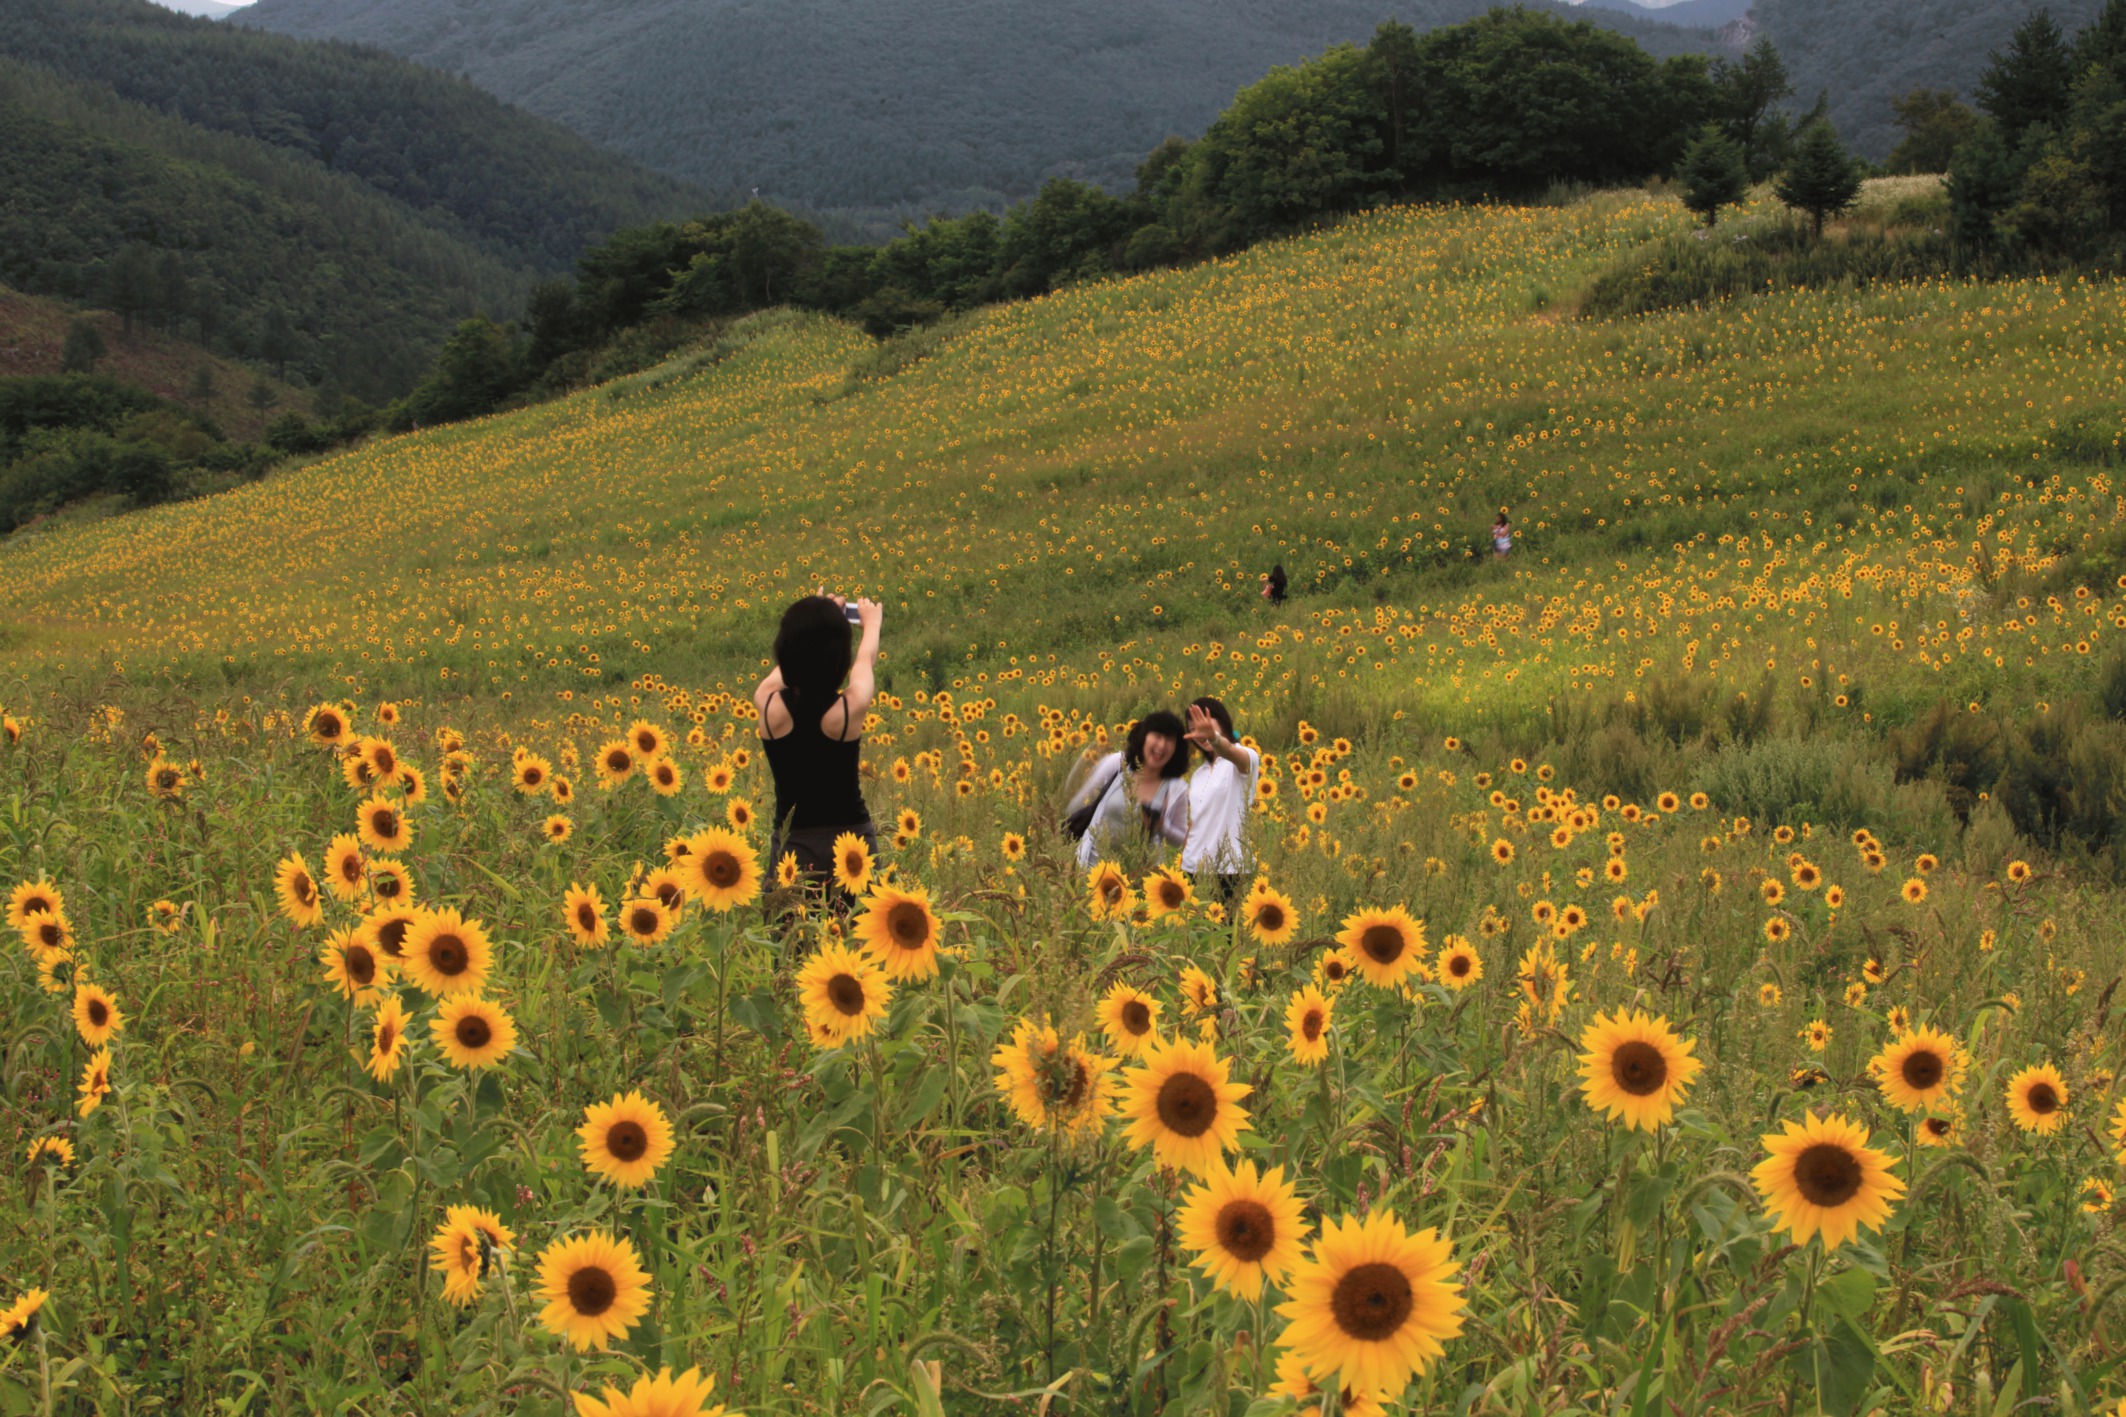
[230,0,1714,210]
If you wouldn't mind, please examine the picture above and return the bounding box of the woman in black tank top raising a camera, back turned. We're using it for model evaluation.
[753,595,884,888]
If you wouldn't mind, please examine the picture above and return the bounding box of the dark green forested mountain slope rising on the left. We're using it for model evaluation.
[0,0,714,399]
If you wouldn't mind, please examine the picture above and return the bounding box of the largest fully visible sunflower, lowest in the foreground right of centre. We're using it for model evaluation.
[1278,1209,1465,1392]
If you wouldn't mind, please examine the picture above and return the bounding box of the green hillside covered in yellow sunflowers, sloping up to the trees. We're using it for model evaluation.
[0,180,2126,1417]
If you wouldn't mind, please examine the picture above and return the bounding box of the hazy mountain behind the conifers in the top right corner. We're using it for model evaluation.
[1750,0,2103,161]
